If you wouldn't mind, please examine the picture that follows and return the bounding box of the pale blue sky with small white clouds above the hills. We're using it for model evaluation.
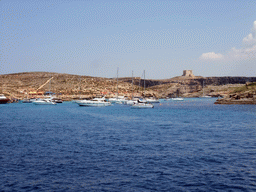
[0,0,256,79]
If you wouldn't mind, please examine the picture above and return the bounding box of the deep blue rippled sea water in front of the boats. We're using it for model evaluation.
[0,99,256,191]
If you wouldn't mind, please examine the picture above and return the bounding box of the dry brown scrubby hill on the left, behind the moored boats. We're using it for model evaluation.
[0,72,158,100]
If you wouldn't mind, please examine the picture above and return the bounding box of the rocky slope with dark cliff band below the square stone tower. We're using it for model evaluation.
[140,76,256,98]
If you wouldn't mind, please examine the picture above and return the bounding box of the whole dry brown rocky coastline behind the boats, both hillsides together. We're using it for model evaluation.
[0,72,256,100]
